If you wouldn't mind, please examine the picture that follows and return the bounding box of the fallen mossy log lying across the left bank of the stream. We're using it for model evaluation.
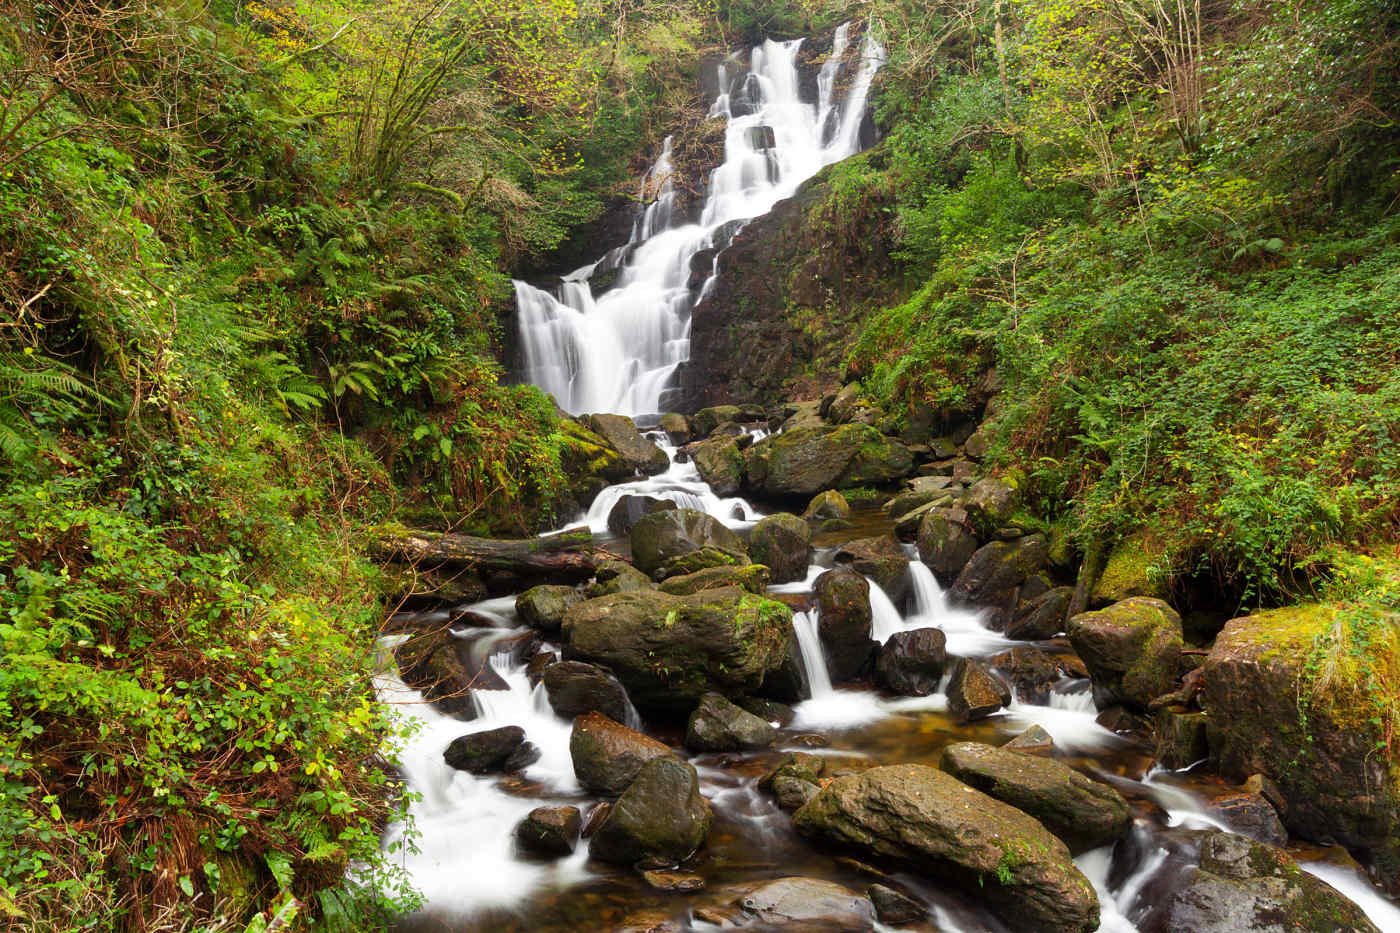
[371,528,622,579]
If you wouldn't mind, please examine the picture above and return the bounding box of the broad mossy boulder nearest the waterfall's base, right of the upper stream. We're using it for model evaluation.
[743,424,914,499]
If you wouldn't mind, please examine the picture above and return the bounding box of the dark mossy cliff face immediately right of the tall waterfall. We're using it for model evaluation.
[679,153,902,410]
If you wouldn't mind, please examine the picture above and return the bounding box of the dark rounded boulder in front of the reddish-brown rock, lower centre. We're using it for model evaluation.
[588,756,714,867]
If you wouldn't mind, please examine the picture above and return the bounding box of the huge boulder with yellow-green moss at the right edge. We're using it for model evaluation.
[1201,605,1400,892]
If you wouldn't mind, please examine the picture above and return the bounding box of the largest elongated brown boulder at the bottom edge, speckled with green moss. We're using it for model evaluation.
[792,765,1099,933]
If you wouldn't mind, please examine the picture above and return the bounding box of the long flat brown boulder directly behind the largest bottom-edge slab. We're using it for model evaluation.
[939,742,1133,855]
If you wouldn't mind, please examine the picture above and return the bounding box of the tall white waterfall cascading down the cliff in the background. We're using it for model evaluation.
[515,24,885,415]
